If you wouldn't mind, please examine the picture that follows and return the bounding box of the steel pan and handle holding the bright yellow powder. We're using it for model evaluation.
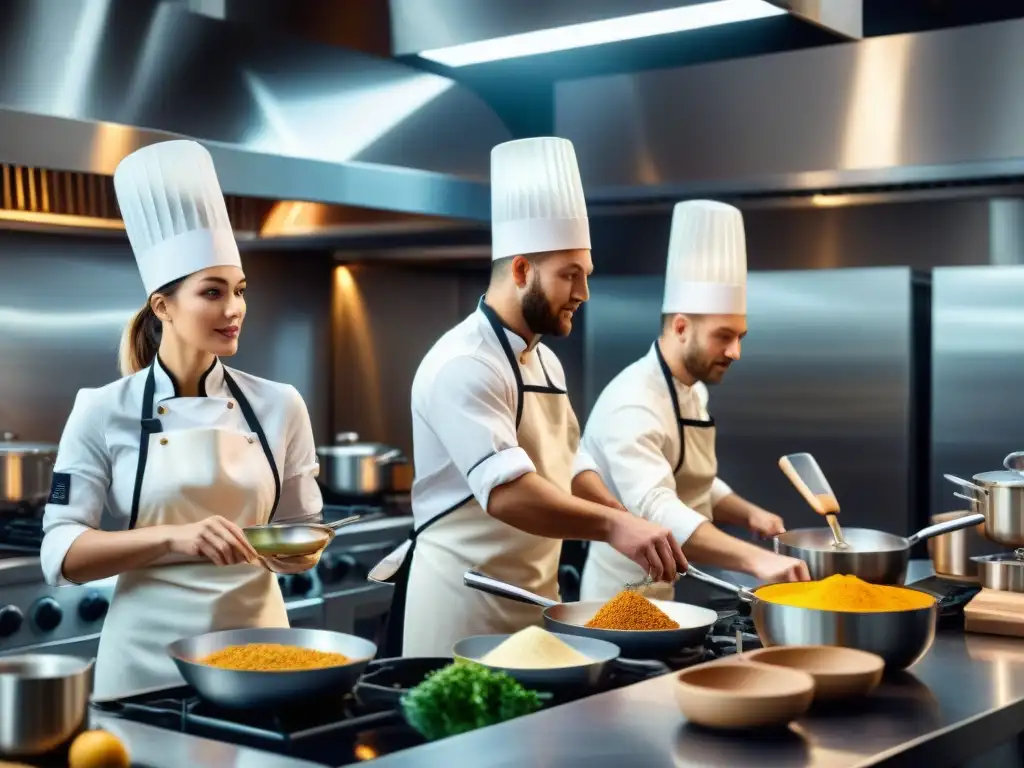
[685,569,939,670]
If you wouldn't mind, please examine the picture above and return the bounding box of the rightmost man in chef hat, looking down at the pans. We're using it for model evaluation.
[581,200,809,607]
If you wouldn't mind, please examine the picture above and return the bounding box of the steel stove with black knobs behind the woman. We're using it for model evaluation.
[0,495,413,657]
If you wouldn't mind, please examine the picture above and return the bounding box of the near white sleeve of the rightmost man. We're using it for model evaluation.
[584,406,708,545]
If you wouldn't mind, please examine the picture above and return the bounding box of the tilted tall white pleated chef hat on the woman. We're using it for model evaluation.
[114,141,242,294]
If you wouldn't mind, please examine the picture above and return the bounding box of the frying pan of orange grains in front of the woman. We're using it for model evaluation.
[167,628,377,710]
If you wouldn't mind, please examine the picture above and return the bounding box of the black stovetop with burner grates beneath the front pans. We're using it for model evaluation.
[93,611,760,766]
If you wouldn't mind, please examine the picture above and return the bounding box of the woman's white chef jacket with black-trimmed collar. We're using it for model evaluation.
[40,360,324,586]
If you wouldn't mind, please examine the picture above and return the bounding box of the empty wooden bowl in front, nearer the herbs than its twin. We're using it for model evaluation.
[676,659,814,729]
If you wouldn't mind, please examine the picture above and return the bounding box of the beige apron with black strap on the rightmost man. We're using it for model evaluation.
[580,342,718,605]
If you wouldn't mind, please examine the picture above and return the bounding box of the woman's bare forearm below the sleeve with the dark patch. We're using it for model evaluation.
[62,525,171,584]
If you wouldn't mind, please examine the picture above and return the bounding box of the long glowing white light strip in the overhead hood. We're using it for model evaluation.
[419,0,787,67]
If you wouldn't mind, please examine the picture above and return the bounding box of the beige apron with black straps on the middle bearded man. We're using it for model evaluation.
[380,303,580,656]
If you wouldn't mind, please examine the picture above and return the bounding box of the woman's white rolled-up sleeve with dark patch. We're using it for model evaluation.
[39,389,111,587]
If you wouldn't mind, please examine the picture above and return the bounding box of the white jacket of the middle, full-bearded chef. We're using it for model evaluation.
[412,309,598,527]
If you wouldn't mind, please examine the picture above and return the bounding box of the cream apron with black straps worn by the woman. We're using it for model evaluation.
[93,368,288,698]
